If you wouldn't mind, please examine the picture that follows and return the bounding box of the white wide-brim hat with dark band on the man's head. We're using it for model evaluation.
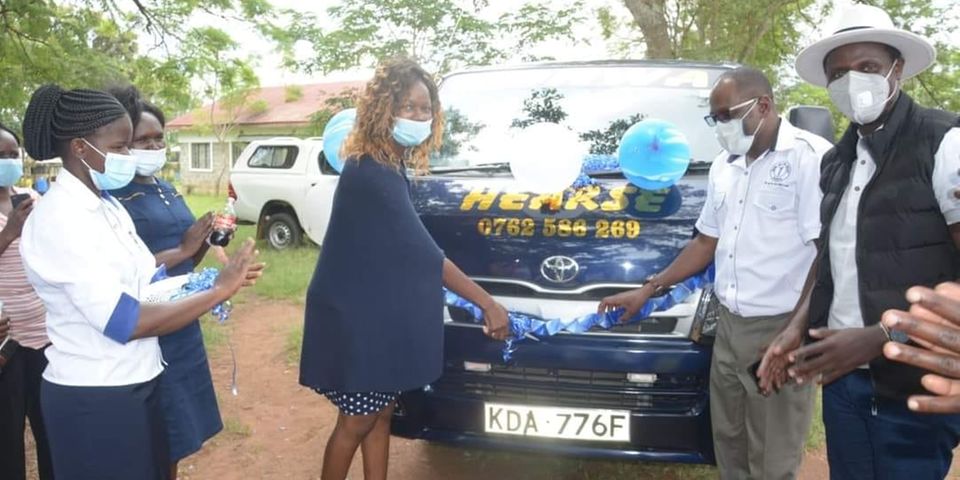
[796,4,937,87]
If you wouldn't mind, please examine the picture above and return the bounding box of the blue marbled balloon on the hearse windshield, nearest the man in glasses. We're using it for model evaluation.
[617,118,690,190]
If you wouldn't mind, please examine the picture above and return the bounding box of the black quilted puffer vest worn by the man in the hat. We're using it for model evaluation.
[810,93,960,399]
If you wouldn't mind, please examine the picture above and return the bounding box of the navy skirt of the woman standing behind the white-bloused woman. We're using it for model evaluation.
[159,321,223,463]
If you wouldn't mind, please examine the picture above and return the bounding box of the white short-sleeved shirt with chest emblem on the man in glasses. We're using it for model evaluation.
[697,119,831,317]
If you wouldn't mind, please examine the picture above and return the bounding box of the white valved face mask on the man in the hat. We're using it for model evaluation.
[827,62,899,125]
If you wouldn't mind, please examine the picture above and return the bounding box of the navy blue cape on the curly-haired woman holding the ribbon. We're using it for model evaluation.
[300,157,444,392]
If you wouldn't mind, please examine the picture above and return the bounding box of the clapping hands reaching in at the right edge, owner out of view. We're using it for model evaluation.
[882,283,960,413]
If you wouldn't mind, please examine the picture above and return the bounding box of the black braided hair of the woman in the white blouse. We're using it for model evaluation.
[23,84,127,160]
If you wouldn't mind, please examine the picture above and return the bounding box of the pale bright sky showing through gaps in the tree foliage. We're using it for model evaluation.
[200,0,960,86]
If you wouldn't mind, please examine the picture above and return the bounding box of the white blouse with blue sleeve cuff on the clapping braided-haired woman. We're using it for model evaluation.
[20,169,163,386]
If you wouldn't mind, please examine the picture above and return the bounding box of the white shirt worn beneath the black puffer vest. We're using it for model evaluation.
[828,128,960,329]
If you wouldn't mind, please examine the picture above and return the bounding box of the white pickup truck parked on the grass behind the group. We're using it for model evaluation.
[229,137,339,250]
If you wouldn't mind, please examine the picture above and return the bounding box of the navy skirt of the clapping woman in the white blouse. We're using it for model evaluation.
[40,377,170,480]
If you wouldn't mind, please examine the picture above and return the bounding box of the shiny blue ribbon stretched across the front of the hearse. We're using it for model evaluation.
[443,265,714,362]
